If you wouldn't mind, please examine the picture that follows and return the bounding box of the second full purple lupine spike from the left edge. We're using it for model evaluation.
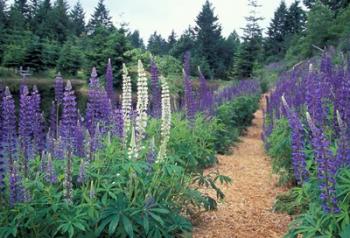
[19,86,34,177]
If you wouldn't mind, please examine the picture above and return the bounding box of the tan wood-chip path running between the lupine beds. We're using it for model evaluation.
[193,97,291,238]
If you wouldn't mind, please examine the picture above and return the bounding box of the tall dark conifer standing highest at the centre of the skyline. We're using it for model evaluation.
[194,0,223,74]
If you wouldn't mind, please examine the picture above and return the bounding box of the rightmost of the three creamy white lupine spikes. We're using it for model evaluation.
[157,78,171,162]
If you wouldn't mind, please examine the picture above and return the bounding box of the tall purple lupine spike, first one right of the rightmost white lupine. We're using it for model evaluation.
[183,51,196,126]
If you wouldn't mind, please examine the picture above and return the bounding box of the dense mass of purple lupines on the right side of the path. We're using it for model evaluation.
[263,54,350,213]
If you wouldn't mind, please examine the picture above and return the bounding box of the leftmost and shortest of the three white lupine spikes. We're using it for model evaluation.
[122,64,132,138]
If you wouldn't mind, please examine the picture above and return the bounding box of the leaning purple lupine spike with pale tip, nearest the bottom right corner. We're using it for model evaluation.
[306,113,339,213]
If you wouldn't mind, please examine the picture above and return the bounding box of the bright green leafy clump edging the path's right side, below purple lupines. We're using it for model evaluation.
[268,118,294,185]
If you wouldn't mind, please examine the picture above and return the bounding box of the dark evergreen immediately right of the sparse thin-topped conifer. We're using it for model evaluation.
[265,1,288,59]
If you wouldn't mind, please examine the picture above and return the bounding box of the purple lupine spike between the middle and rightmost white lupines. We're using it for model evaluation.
[150,60,161,118]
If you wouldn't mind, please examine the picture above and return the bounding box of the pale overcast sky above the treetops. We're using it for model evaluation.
[68,0,294,40]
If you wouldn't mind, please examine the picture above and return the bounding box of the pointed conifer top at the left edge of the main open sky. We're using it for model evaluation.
[88,0,113,33]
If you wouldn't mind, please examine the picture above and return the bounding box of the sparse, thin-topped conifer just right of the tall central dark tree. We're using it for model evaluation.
[236,0,263,78]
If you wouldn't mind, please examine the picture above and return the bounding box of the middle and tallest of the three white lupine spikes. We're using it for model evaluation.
[136,60,148,143]
